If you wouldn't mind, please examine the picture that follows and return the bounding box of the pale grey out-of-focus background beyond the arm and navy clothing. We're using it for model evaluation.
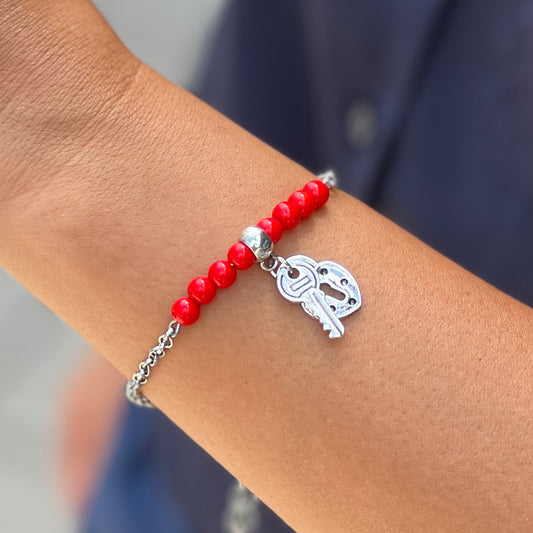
[0,0,224,533]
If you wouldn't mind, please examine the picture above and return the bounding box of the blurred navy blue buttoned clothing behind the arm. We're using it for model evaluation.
[81,0,533,533]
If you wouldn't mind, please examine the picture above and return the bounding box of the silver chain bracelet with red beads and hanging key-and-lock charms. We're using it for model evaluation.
[125,171,361,407]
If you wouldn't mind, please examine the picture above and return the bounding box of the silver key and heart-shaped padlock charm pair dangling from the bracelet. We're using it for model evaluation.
[272,255,361,339]
